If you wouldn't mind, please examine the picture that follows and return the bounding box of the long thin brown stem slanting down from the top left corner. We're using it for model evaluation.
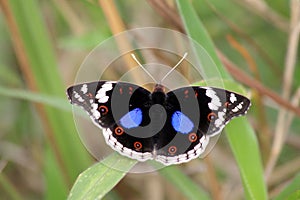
[0,0,70,185]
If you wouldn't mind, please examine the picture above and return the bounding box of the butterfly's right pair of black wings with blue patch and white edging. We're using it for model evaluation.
[152,87,250,164]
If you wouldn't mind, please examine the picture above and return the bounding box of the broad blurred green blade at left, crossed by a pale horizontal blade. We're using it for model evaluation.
[9,0,90,183]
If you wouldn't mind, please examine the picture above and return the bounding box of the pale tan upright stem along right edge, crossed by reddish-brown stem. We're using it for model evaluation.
[265,0,300,180]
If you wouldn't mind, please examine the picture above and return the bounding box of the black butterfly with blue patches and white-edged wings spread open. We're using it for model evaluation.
[67,81,251,165]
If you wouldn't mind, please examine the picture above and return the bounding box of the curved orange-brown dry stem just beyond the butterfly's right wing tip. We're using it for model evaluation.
[227,35,271,161]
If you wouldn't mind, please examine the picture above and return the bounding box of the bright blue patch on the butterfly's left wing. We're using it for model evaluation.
[120,108,143,128]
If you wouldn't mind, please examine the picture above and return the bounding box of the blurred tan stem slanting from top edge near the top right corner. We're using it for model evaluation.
[232,0,289,32]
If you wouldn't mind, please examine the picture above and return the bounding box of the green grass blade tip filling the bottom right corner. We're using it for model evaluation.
[274,173,300,200]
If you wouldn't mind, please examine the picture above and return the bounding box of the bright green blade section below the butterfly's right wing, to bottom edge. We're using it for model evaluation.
[225,117,267,199]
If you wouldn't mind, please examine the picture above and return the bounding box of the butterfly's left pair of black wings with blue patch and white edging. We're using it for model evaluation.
[67,81,154,161]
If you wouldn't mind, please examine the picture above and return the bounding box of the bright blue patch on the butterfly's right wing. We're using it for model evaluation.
[172,111,194,134]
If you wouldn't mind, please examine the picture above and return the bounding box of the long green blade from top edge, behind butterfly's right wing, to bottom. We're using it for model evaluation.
[176,0,267,199]
